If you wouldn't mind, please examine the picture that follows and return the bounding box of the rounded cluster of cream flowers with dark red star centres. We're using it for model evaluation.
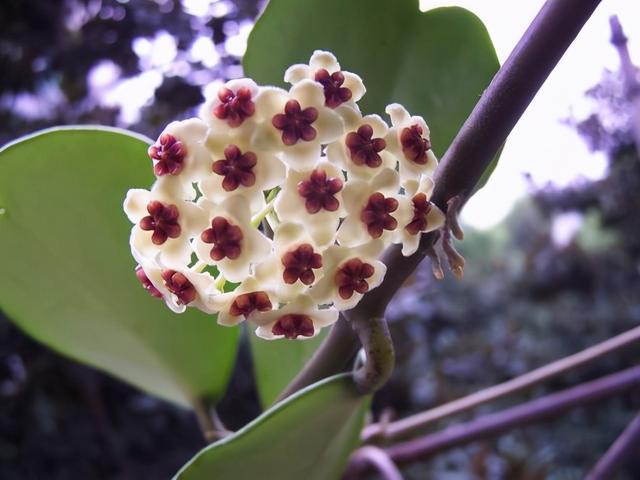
[124,51,445,339]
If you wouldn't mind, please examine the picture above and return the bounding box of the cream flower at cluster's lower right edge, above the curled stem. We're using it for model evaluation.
[311,240,387,310]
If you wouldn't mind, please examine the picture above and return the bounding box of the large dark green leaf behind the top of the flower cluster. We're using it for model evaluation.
[244,0,499,189]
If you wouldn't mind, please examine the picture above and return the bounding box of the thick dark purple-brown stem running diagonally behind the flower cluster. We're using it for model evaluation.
[282,0,600,397]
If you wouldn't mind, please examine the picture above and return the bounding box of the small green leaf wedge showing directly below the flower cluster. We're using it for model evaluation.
[249,329,328,407]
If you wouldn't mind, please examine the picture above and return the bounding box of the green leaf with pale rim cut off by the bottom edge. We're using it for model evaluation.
[174,374,369,480]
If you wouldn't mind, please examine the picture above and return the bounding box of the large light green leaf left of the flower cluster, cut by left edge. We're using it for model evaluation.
[0,128,239,405]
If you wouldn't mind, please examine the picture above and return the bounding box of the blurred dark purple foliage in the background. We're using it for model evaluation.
[0,0,640,480]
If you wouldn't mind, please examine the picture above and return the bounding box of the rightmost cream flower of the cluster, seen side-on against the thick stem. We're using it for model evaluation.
[398,175,445,257]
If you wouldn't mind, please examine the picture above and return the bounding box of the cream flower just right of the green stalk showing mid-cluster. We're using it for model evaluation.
[274,161,344,247]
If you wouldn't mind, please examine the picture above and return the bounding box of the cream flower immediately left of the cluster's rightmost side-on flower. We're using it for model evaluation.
[337,168,402,247]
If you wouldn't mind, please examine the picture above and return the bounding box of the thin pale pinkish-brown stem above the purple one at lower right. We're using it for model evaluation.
[362,326,640,442]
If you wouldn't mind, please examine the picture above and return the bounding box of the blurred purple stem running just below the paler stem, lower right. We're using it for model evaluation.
[347,366,640,478]
